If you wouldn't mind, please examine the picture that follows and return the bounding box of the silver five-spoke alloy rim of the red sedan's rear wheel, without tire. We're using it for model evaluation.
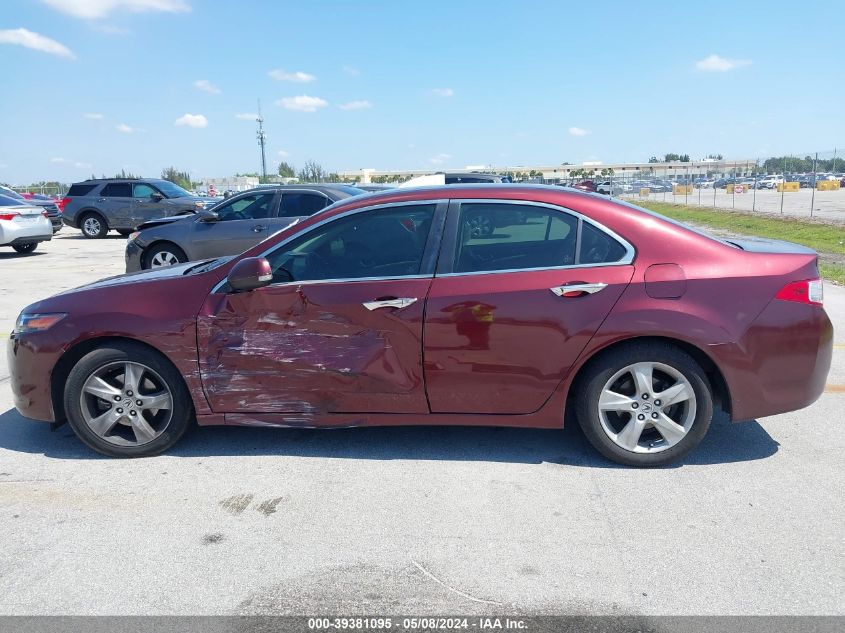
[598,362,696,453]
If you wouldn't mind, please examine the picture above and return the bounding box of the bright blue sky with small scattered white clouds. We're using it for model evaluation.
[0,0,845,184]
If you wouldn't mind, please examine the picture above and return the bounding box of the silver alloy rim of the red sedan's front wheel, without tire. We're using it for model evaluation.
[79,361,173,446]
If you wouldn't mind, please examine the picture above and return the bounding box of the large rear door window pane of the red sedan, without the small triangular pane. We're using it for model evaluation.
[455,203,578,273]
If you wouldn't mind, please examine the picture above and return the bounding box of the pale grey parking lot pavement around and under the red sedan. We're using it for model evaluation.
[0,229,845,615]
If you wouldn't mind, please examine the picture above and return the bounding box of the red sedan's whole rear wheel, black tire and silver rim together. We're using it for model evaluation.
[577,343,713,466]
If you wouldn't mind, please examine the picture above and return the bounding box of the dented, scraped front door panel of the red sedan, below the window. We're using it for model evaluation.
[198,276,431,415]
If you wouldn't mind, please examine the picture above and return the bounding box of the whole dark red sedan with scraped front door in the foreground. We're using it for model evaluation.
[8,185,832,466]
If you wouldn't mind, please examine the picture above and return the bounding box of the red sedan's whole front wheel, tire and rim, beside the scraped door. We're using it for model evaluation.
[64,343,193,457]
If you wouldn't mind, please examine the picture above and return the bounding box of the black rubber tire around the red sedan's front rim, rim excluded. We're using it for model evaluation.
[64,342,194,457]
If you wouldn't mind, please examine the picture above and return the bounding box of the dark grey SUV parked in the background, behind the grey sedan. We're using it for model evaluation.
[60,178,217,238]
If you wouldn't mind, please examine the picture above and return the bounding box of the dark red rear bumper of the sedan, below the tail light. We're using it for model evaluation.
[708,300,833,421]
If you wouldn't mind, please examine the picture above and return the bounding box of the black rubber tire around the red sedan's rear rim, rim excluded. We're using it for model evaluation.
[573,342,713,467]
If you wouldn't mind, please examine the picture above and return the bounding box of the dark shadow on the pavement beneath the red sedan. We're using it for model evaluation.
[0,409,778,468]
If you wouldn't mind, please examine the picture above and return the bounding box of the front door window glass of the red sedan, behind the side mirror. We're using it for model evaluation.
[268,204,435,282]
